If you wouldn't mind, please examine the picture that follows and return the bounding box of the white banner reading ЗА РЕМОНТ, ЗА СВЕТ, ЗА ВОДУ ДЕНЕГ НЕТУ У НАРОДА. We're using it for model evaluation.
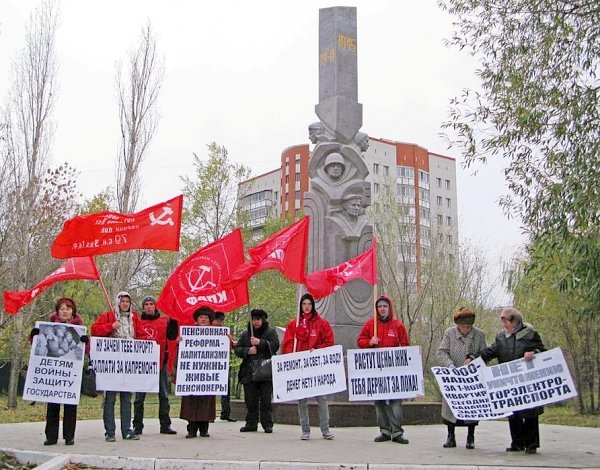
[272,345,346,403]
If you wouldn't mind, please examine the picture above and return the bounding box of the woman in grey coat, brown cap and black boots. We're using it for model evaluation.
[437,307,487,449]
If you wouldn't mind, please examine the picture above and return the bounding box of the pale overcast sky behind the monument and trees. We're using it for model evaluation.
[0,0,523,303]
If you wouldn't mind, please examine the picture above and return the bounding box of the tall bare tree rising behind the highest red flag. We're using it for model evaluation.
[108,22,164,289]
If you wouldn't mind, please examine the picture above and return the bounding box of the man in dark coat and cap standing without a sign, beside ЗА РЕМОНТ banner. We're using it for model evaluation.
[235,309,279,433]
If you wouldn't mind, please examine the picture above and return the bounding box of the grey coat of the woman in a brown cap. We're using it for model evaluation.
[437,326,487,424]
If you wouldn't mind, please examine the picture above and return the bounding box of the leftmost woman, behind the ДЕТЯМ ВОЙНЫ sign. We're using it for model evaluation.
[31,297,88,446]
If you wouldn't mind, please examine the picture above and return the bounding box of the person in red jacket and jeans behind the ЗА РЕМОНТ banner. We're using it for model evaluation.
[281,294,333,441]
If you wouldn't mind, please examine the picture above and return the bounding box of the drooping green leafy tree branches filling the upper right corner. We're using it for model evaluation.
[439,0,600,235]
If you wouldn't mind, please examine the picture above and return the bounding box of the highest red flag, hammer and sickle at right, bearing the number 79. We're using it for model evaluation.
[52,195,183,258]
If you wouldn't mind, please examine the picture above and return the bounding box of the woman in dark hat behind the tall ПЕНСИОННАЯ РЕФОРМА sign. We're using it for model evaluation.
[179,307,216,439]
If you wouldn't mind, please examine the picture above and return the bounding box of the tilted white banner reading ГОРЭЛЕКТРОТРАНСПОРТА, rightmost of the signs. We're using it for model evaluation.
[483,348,577,412]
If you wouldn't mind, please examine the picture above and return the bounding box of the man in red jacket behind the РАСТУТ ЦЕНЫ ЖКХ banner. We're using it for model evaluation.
[357,295,410,444]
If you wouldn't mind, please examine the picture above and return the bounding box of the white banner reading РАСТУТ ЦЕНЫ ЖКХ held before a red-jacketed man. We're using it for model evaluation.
[346,346,425,401]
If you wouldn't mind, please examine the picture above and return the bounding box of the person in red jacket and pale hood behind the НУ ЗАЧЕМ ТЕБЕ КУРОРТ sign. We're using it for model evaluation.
[91,292,140,442]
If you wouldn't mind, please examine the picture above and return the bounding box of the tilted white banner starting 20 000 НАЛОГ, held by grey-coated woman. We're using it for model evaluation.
[431,357,506,421]
